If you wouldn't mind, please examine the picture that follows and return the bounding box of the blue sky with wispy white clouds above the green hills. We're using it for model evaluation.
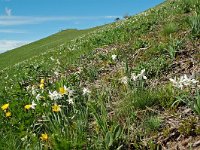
[0,0,164,53]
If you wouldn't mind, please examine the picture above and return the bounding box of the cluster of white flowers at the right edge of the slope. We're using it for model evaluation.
[169,74,199,89]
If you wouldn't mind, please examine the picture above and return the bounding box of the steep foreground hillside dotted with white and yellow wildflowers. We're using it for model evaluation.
[0,0,200,150]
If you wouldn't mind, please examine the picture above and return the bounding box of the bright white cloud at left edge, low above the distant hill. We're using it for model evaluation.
[0,40,30,53]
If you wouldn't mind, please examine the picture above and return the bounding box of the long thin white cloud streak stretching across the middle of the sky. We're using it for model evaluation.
[0,16,121,26]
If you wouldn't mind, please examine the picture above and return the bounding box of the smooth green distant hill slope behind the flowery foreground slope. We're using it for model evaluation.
[0,28,96,69]
